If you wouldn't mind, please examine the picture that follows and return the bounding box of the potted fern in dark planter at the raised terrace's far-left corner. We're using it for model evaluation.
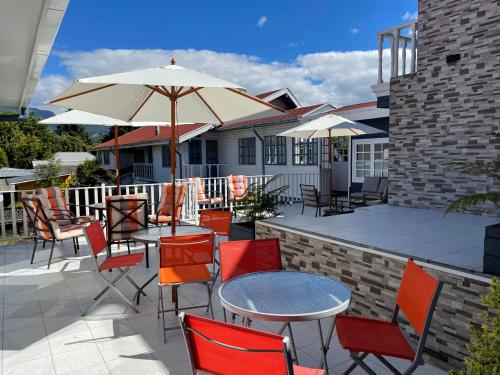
[229,175,288,241]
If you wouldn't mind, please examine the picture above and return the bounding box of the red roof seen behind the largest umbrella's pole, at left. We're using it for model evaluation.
[95,124,205,148]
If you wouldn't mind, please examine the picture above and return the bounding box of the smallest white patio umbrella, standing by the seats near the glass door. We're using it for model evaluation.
[279,114,384,211]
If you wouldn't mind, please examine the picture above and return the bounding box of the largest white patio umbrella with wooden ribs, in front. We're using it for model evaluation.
[49,59,283,233]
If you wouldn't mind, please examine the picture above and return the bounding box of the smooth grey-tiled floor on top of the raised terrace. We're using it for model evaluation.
[276,203,500,272]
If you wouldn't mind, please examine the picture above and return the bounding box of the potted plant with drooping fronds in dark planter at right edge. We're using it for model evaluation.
[446,160,500,275]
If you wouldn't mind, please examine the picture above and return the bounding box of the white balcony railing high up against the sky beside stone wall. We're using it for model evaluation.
[377,20,417,84]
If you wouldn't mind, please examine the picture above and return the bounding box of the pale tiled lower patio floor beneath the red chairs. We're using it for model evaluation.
[0,236,444,375]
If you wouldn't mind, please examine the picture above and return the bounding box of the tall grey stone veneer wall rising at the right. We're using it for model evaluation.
[389,0,500,216]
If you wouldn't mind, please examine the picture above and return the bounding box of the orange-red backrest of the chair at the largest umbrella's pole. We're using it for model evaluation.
[160,233,215,268]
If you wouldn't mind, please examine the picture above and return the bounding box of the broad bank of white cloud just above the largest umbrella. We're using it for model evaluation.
[32,49,389,109]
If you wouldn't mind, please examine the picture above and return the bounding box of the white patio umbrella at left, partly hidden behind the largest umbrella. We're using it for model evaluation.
[39,109,176,191]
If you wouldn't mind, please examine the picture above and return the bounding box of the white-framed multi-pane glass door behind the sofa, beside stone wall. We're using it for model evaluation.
[352,138,389,182]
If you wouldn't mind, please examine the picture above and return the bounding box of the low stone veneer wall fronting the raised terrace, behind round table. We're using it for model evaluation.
[256,223,489,369]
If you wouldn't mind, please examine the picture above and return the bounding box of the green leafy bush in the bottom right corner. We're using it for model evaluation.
[450,279,500,375]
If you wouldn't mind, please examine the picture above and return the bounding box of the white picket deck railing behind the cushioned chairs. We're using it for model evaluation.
[0,173,319,239]
